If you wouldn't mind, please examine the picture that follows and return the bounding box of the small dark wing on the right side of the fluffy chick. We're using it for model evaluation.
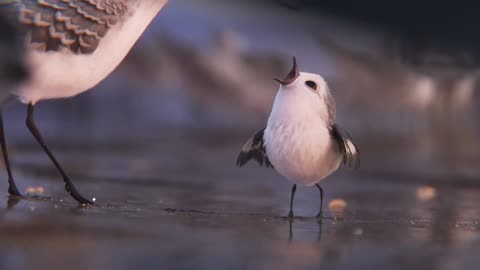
[330,124,360,168]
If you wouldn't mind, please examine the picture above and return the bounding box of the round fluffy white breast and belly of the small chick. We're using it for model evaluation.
[264,90,342,185]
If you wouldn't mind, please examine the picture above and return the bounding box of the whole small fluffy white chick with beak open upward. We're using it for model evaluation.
[237,58,360,218]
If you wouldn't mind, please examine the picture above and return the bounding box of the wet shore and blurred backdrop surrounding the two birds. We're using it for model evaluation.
[0,0,480,269]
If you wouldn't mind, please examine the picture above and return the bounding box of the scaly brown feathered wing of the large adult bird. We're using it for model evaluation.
[1,0,129,54]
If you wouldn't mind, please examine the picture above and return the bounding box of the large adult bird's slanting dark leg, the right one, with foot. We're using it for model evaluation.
[26,103,93,204]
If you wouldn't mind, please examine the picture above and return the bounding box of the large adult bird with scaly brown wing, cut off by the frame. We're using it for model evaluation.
[0,0,168,204]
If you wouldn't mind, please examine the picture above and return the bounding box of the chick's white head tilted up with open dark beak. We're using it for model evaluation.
[274,57,335,124]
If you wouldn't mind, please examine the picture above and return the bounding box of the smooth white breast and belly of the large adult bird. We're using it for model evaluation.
[14,0,167,103]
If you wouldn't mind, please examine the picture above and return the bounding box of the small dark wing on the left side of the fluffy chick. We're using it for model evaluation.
[237,128,273,168]
